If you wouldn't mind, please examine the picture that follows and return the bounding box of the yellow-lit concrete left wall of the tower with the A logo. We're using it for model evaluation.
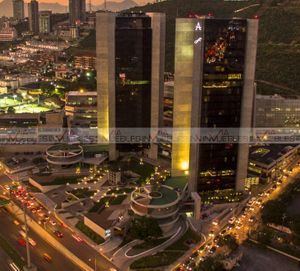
[172,19,196,176]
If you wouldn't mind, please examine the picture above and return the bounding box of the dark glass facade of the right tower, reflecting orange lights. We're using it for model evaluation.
[197,19,247,191]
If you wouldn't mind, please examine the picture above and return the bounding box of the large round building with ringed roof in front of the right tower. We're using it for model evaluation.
[131,185,180,232]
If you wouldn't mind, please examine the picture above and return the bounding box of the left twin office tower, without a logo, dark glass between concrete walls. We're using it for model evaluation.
[96,12,165,159]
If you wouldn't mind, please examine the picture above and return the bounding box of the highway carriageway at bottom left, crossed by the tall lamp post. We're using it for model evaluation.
[0,211,81,271]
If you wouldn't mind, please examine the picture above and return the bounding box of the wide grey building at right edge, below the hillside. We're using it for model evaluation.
[254,95,300,128]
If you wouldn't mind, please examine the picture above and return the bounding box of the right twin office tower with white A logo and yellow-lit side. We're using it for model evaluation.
[172,18,258,192]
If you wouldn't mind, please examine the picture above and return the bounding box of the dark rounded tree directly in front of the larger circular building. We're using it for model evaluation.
[128,216,162,240]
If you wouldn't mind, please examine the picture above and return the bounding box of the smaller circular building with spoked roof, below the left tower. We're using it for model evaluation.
[46,144,83,166]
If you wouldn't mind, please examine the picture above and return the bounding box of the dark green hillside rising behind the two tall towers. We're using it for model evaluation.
[127,0,300,95]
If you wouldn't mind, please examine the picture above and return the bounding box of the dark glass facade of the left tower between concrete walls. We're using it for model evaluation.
[115,14,152,151]
